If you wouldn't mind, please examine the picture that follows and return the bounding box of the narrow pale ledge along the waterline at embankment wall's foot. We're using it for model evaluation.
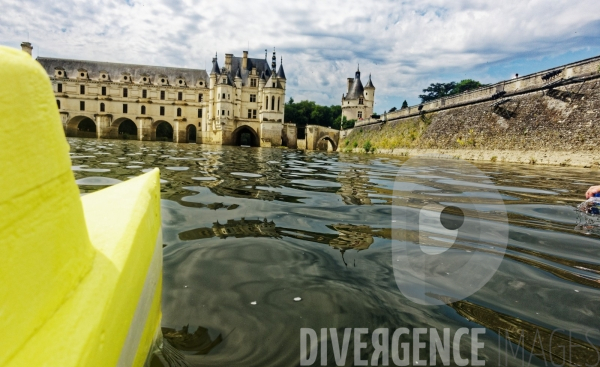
[342,148,600,168]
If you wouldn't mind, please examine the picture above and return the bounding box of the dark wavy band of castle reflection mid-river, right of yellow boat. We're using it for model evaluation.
[179,218,391,263]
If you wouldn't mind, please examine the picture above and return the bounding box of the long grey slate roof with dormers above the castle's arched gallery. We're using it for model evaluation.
[36,57,208,85]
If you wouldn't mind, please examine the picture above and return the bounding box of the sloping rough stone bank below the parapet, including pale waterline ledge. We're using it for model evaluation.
[338,78,600,168]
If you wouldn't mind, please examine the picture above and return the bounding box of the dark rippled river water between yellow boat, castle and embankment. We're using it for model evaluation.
[68,138,600,366]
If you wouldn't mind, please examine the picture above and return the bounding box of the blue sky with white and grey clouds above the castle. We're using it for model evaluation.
[0,0,600,113]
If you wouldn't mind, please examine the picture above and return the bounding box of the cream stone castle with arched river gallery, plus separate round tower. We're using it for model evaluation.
[21,42,375,149]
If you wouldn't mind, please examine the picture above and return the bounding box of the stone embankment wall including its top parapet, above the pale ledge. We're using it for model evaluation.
[339,57,600,166]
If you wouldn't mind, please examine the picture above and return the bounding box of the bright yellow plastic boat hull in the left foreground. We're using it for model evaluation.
[0,47,162,367]
